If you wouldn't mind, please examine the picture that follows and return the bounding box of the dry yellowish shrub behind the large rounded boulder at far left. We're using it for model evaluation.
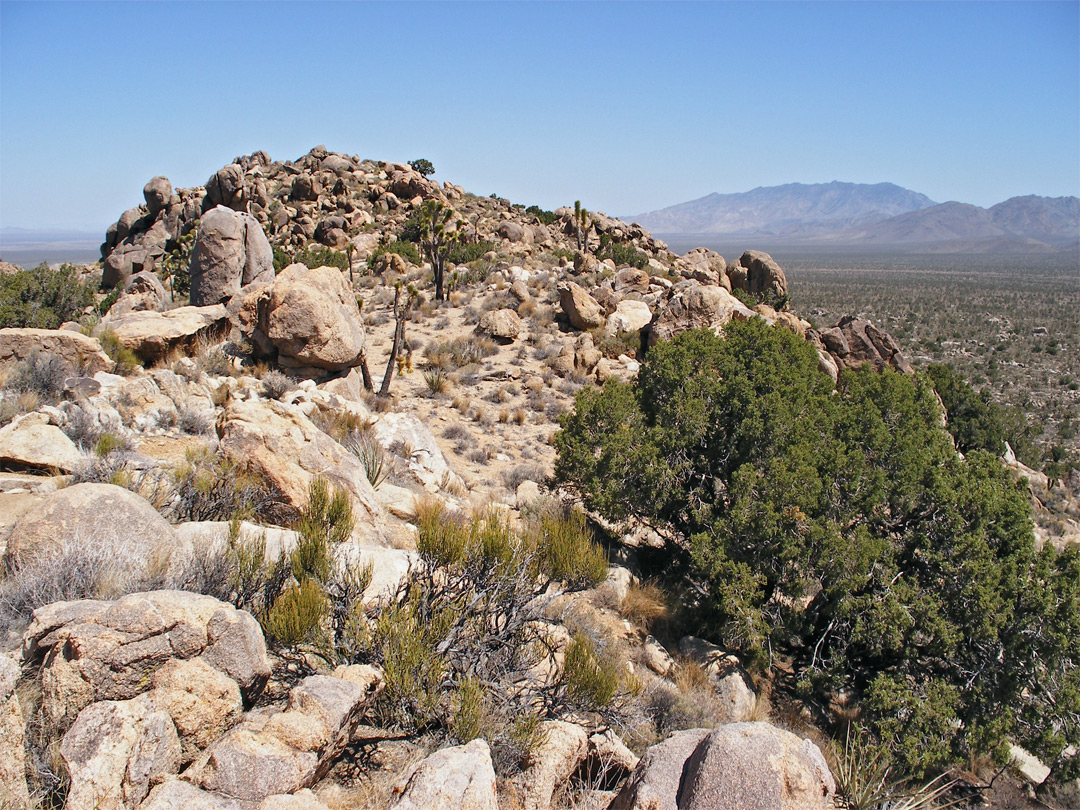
[164,448,291,524]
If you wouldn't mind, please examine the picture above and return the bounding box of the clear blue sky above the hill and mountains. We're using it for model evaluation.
[0,0,1080,232]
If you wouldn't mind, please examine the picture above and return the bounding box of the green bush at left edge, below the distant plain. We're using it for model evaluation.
[0,264,96,329]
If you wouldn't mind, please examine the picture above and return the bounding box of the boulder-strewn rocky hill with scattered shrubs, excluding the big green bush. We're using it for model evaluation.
[0,147,1067,810]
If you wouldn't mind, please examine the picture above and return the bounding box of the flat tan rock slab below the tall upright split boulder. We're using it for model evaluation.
[94,303,228,363]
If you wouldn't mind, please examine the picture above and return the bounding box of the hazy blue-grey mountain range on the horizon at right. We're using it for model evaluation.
[622,183,1080,253]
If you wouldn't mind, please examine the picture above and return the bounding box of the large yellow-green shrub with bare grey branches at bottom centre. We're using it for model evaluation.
[359,500,609,773]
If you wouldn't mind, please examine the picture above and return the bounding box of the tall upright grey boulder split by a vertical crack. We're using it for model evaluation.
[190,205,273,307]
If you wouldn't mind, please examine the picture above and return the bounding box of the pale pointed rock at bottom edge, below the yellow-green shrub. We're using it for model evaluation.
[392,740,498,810]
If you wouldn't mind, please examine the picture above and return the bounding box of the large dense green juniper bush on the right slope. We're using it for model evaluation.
[554,319,1080,777]
